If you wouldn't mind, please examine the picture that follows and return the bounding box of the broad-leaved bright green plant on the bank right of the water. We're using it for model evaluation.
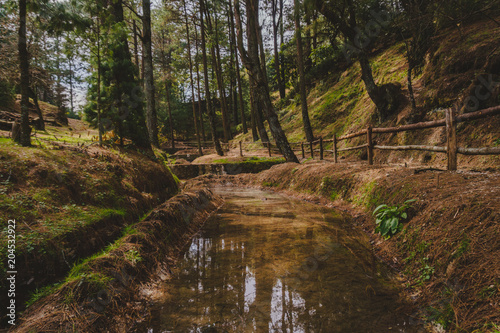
[373,199,416,239]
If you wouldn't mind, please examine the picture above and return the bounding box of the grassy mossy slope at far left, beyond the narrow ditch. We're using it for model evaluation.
[0,139,178,320]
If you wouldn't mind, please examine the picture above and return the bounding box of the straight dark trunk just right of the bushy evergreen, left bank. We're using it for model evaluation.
[142,0,159,147]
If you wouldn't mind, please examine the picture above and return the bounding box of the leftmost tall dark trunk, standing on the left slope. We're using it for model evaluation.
[17,0,31,147]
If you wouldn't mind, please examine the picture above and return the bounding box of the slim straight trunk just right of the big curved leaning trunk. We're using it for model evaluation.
[294,0,314,142]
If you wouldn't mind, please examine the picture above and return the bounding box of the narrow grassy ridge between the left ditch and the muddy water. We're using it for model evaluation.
[13,188,222,332]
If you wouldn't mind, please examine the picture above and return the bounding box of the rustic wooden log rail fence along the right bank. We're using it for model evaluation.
[178,106,500,170]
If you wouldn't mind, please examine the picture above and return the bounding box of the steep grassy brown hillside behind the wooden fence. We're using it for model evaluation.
[235,16,500,167]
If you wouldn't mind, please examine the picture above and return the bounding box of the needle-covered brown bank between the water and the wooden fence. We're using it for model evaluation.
[190,161,500,332]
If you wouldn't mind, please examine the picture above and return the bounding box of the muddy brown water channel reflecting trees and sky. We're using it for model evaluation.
[141,188,419,333]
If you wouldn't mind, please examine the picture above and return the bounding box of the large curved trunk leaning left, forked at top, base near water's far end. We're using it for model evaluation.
[235,0,298,163]
